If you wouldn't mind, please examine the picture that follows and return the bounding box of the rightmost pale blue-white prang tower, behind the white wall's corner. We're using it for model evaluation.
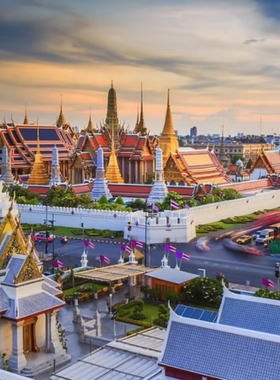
[148,148,168,203]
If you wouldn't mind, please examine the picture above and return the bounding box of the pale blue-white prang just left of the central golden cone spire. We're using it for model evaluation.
[91,147,112,199]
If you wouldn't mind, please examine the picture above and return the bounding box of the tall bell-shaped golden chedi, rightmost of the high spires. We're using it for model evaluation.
[159,90,179,166]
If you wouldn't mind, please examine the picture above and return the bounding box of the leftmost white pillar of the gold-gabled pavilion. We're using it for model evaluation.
[10,321,26,373]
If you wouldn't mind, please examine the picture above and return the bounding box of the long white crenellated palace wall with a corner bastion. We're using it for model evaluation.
[18,190,280,244]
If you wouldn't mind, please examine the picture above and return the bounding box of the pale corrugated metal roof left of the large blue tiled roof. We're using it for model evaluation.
[51,328,165,380]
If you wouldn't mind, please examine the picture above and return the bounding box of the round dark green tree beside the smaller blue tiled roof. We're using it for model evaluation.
[184,277,223,306]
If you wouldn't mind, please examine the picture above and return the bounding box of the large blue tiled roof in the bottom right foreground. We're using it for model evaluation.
[160,320,280,380]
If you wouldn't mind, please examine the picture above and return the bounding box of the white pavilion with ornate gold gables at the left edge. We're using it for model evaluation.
[0,187,70,377]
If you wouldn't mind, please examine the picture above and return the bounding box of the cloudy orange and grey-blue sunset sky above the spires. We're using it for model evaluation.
[0,0,280,136]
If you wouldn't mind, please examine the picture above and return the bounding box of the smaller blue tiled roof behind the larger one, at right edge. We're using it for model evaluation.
[219,297,280,335]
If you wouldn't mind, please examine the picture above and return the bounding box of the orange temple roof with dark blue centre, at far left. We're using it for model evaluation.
[0,124,75,168]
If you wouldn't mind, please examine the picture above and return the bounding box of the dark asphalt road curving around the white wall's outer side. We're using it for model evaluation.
[41,232,280,287]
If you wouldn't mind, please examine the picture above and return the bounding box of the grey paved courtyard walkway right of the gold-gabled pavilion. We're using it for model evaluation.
[35,285,140,380]
